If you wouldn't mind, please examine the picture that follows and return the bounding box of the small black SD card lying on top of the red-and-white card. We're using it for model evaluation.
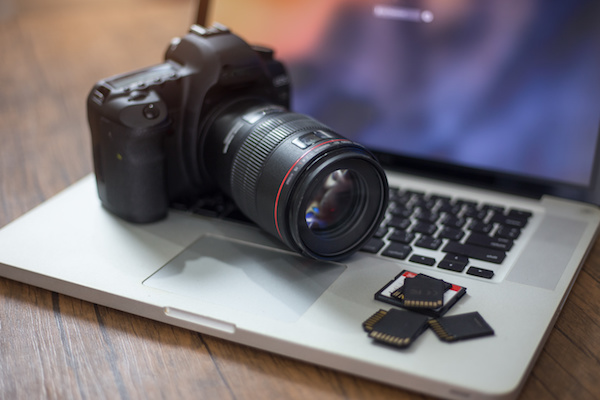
[392,274,450,308]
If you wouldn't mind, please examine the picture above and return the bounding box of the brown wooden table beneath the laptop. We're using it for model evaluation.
[0,0,600,400]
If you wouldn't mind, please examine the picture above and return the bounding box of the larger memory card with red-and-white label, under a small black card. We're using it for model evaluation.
[375,270,467,317]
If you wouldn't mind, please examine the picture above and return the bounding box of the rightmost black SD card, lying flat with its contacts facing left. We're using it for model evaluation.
[429,311,494,342]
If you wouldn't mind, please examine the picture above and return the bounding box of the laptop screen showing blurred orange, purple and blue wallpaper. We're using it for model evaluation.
[209,0,600,197]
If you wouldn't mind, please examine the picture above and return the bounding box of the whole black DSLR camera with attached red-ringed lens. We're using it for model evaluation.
[87,24,388,260]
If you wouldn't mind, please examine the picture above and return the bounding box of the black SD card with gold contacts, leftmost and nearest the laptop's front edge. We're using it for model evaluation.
[363,309,429,348]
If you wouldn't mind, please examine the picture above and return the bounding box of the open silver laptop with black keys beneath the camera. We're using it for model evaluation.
[0,0,600,399]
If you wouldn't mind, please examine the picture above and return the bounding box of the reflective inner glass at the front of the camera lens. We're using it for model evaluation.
[305,169,358,234]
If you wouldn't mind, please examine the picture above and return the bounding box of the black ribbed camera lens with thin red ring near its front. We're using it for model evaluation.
[198,99,388,260]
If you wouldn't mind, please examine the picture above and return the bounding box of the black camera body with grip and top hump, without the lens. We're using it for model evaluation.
[87,25,289,223]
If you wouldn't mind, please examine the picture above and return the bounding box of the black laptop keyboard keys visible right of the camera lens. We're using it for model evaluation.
[362,188,532,279]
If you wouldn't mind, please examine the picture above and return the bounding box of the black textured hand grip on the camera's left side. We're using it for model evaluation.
[91,96,170,223]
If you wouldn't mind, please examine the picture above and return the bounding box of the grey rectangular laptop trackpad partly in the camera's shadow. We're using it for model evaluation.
[144,236,346,322]
